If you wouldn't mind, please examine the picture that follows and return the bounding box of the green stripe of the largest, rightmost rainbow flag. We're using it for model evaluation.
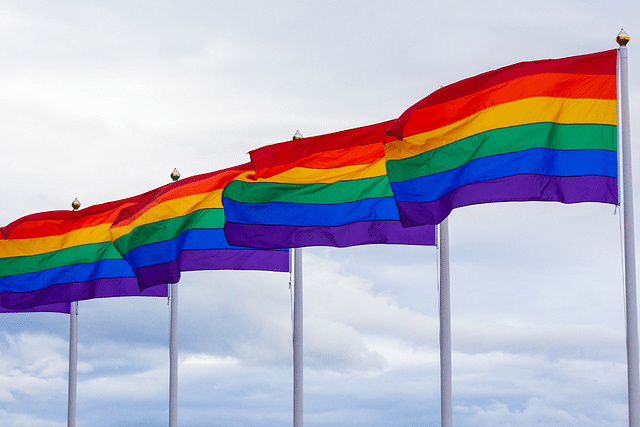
[387,123,617,182]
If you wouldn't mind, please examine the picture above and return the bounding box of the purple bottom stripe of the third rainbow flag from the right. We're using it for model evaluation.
[136,249,289,288]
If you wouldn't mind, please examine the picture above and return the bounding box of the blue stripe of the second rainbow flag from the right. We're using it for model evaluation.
[222,197,400,227]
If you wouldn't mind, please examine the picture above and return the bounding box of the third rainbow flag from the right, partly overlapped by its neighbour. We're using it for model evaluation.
[109,163,289,288]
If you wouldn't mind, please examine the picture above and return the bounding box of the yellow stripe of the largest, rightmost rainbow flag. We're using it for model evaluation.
[385,97,616,160]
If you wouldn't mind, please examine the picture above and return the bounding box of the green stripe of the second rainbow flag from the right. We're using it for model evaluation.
[222,175,393,205]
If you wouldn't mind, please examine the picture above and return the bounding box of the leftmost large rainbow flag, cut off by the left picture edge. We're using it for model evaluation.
[0,198,168,312]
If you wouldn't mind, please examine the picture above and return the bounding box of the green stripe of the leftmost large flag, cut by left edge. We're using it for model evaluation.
[0,242,122,277]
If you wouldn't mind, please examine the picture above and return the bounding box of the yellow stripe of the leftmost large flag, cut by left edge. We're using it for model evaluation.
[0,223,111,258]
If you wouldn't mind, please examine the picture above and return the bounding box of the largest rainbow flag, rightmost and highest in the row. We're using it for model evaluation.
[385,50,618,226]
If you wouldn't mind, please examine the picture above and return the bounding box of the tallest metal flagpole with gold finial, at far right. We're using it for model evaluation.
[616,30,640,427]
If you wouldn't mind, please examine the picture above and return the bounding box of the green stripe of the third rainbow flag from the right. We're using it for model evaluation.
[114,208,224,254]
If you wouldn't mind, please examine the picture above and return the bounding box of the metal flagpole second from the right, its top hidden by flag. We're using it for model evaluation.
[438,217,452,427]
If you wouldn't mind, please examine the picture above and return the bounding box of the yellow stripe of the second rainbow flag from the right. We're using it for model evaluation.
[235,158,387,184]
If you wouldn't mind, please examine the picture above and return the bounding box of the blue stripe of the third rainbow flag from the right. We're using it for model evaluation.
[124,228,288,270]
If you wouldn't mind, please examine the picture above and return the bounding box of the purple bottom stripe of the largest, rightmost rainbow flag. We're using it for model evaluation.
[397,175,618,227]
